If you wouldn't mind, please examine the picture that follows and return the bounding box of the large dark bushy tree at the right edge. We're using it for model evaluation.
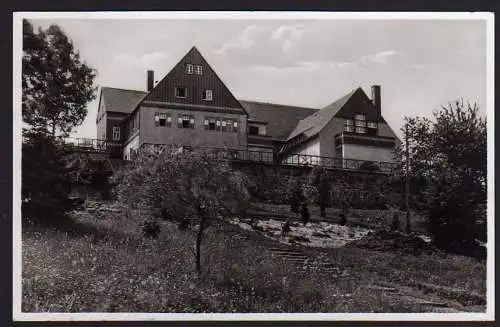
[401,101,487,252]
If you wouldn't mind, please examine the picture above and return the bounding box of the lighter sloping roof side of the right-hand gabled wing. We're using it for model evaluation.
[286,88,363,141]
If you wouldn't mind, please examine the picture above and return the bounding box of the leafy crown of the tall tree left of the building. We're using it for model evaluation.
[22,20,96,137]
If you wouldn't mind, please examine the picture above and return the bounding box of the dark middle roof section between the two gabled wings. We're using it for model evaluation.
[239,100,318,141]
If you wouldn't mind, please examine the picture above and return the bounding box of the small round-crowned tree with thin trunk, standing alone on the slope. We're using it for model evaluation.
[117,149,249,274]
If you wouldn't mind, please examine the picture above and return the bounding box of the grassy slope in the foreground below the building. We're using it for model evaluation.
[23,204,486,312]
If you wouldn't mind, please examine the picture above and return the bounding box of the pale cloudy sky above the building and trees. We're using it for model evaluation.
[31,18,487,138]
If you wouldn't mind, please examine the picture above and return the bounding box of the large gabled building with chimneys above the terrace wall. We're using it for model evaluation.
[96,47,399,167]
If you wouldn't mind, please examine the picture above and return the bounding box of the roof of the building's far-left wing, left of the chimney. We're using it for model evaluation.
[101,87,147,114]
